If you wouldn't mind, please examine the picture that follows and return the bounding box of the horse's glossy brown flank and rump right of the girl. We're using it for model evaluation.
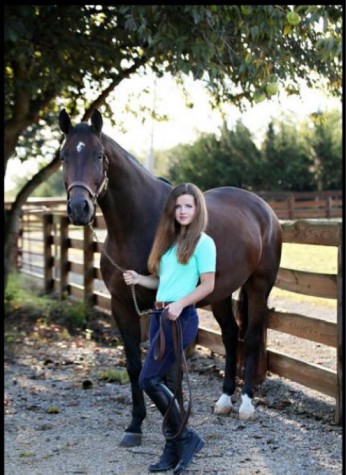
[205,187,281,295]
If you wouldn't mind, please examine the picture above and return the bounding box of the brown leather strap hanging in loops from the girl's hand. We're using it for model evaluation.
[154,311,192,440]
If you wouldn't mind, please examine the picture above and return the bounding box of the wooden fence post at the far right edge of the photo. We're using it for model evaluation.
[335,226,344,425]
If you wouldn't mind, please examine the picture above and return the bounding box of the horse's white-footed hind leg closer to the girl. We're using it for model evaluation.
[211,296,238,414]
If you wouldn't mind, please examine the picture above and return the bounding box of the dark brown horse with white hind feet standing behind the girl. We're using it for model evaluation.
[59,110,282,446]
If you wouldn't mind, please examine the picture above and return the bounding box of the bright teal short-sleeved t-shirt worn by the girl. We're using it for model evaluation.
[156,233,216,302]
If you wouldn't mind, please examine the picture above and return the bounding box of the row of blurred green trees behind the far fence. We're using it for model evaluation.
[166,110,342,191]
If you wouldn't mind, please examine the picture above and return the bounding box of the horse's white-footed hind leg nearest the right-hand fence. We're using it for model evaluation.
[239,277,271,420]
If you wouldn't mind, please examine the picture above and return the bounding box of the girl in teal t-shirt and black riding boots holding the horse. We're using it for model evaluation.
[123,183,216,475]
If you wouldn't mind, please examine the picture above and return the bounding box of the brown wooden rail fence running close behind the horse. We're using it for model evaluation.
[12,209,343,424]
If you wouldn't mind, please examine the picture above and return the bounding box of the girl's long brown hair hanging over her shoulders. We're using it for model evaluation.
[148,183,208,275]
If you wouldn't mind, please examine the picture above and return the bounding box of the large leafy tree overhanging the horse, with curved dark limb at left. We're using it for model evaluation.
[4,5,343,282]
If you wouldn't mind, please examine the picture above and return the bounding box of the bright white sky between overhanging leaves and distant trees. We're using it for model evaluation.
[5,75,342,192]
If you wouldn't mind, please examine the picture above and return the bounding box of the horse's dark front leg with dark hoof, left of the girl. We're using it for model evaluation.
[112,298,146,447]
